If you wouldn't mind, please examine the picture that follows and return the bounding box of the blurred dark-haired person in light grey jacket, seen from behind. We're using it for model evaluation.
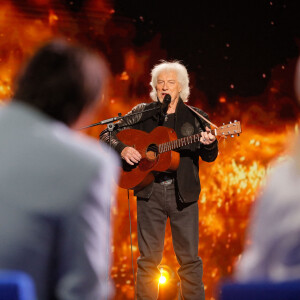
[0,40,118,300]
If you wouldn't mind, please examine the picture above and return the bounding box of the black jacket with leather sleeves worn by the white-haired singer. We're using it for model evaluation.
[100,99,218,203]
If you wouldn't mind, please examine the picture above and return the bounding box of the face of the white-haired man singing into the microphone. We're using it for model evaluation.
[156,71,181,103]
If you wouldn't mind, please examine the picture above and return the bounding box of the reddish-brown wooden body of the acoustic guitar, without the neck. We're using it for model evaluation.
[117,126,180,190]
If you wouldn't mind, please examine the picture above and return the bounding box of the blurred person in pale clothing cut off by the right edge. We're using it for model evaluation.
[236,59,300,281]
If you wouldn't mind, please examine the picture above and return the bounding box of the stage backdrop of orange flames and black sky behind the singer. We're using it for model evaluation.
[0,0,300,300]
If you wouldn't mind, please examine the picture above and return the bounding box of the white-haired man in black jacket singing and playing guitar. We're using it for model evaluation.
[101,62,218,300]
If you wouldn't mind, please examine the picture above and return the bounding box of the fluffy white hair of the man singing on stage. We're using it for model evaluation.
[150,61,190,102]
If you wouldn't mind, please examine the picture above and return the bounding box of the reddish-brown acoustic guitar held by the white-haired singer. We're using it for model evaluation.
[117,121,242,190]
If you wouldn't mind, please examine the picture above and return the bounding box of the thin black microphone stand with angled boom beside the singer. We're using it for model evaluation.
[78,105,161,300]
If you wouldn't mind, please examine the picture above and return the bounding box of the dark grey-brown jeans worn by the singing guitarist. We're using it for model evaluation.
[137,183,205,300]
